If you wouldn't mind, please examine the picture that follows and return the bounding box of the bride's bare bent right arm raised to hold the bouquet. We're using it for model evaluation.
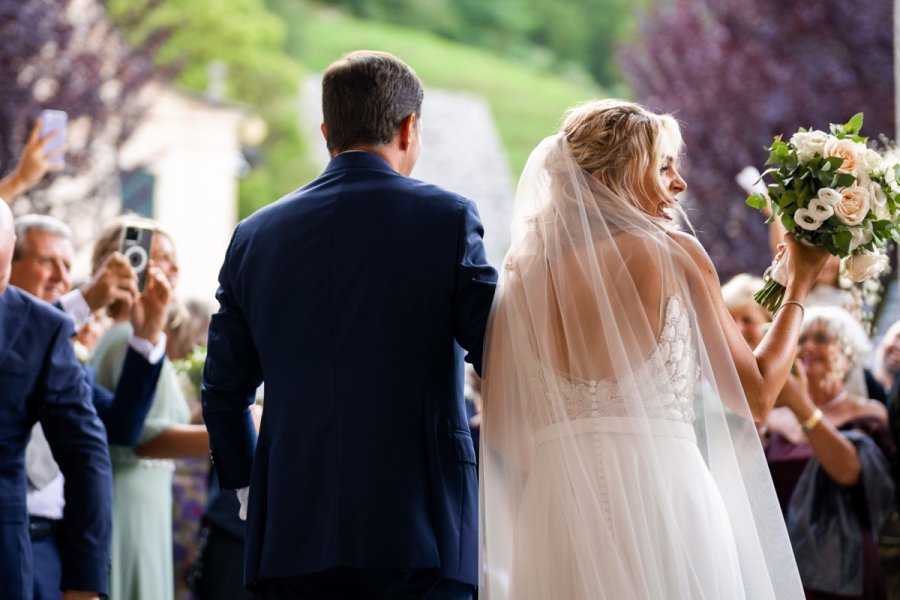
[669,231,828,421]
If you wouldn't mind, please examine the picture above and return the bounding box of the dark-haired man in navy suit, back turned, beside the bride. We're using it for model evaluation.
[203,51,497,600]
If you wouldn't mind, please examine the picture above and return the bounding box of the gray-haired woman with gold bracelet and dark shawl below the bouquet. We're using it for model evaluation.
[765,306,894,599]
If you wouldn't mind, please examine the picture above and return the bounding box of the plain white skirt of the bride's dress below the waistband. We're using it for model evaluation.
[508,418,746,600]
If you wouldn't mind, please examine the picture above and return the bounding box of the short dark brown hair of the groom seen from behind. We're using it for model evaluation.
[322,50,425,153]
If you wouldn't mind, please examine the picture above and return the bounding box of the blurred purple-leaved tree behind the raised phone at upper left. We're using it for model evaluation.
[0,0,168,219]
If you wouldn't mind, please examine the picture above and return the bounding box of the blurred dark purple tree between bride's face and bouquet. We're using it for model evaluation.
[620,0,894,278]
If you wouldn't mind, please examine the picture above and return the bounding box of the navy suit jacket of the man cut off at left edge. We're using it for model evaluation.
[0,286,112,599]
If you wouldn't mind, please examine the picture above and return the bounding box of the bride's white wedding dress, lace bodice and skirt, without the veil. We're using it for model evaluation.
[509,296,745,600]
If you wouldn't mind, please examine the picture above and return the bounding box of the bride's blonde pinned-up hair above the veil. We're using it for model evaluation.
[560,99,682,216]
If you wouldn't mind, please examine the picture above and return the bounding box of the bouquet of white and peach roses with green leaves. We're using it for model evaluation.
[747,113,900,312]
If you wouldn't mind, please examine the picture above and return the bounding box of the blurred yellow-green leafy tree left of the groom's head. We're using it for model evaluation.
[106,0,313,217]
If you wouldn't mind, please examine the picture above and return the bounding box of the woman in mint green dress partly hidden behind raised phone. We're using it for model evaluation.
[91,219,209,600]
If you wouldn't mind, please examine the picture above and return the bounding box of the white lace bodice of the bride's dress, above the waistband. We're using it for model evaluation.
[533,296,700,427]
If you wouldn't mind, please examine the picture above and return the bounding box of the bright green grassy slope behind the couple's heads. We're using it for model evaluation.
[288,10,601,177]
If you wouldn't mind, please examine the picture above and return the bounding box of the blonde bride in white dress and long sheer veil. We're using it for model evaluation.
[481,100,827,600]
